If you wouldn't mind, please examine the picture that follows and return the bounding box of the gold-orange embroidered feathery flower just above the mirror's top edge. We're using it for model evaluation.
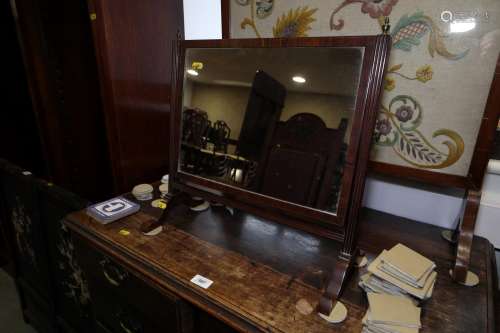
[273,6,318,38]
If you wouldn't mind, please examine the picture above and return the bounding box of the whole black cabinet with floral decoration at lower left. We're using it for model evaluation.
[0,160,93,332]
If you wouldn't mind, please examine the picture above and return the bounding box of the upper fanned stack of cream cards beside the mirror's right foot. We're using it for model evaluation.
[359,244,437,300]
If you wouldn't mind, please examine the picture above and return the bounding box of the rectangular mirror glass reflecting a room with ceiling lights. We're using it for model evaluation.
[179,47,363,212]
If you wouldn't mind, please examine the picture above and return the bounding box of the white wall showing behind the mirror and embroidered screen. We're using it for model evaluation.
[184,0,500,248]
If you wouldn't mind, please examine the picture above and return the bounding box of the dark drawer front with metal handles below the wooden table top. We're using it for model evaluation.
[75,238,194,333]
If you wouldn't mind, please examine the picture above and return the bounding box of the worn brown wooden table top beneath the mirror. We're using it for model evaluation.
[66,197,497,333]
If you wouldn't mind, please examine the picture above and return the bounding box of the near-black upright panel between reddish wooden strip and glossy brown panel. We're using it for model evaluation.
[39,0,112,200]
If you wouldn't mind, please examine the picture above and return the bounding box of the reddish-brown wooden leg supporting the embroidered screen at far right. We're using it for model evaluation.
[452,190,481,283]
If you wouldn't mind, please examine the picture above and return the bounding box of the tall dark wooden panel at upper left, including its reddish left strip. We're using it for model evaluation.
[12,0,111,199]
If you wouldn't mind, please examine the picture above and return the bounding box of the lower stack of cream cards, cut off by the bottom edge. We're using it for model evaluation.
[362,293,421,333]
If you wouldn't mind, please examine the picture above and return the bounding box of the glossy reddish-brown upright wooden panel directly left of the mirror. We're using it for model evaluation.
[89,0,183,192]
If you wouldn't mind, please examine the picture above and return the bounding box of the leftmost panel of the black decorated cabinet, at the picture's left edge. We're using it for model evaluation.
[0,163,53,332]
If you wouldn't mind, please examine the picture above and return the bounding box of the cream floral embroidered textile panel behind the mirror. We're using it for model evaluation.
[230,0,500,176]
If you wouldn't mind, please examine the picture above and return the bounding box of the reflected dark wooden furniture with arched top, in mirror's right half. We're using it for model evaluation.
[259,113,347,211]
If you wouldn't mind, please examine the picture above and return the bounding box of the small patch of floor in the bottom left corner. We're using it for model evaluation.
[0,269,36,333]
